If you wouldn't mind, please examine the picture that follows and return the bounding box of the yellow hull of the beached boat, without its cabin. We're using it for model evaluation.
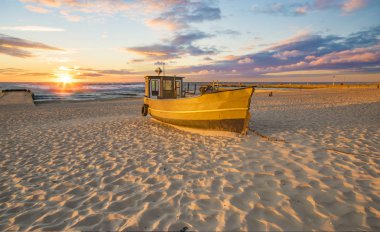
[144,88,254,133]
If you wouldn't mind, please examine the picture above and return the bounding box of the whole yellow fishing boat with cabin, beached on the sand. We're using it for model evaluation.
[141,72,254,134]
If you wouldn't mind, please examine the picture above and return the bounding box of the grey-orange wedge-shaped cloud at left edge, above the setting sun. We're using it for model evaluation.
[0,34,62,58]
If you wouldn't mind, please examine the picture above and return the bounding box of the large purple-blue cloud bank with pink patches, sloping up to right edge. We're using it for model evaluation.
[169,26,380,78]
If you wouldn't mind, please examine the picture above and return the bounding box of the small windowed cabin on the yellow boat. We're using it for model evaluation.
[145,76,184,99]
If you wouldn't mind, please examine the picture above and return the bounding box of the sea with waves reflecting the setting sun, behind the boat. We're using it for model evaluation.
[0,82,374,103]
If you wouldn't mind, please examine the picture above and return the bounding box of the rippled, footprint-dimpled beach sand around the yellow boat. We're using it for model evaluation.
[0,89,380,231]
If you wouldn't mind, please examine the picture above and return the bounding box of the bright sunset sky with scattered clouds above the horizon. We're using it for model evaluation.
[0,0,380,82]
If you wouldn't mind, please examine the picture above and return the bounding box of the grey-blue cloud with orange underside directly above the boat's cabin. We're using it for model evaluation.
[126,31,218,60]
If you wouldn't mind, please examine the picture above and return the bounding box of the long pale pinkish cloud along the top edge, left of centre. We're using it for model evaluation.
[20,0,221,30]
